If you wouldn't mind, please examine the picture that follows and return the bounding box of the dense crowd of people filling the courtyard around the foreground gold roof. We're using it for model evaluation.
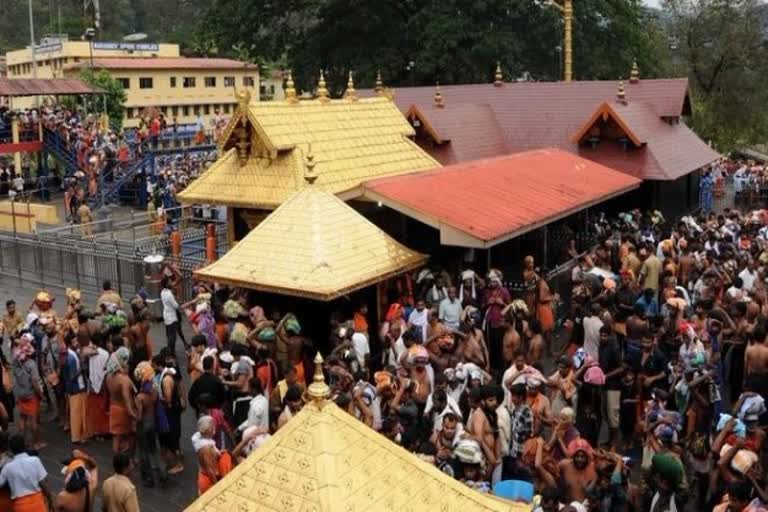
[0,198,768,512]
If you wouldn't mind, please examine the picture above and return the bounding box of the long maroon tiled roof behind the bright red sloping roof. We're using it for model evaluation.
[360,79,719,180]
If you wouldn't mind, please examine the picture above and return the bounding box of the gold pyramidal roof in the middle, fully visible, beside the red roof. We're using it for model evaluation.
[195,185,427,301]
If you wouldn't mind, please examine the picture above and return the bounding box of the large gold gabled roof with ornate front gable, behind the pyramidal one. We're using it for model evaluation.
[179,97,440,210]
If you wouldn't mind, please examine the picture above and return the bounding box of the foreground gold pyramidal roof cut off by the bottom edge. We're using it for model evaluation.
[186,402,530,512]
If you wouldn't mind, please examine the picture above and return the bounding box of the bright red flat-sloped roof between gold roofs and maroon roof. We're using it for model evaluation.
[362,149,640,247]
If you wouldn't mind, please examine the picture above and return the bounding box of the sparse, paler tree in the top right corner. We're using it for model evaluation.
[664,0,768,151]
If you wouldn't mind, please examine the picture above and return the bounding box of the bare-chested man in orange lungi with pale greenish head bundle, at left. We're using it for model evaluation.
[106,347,136,454]
